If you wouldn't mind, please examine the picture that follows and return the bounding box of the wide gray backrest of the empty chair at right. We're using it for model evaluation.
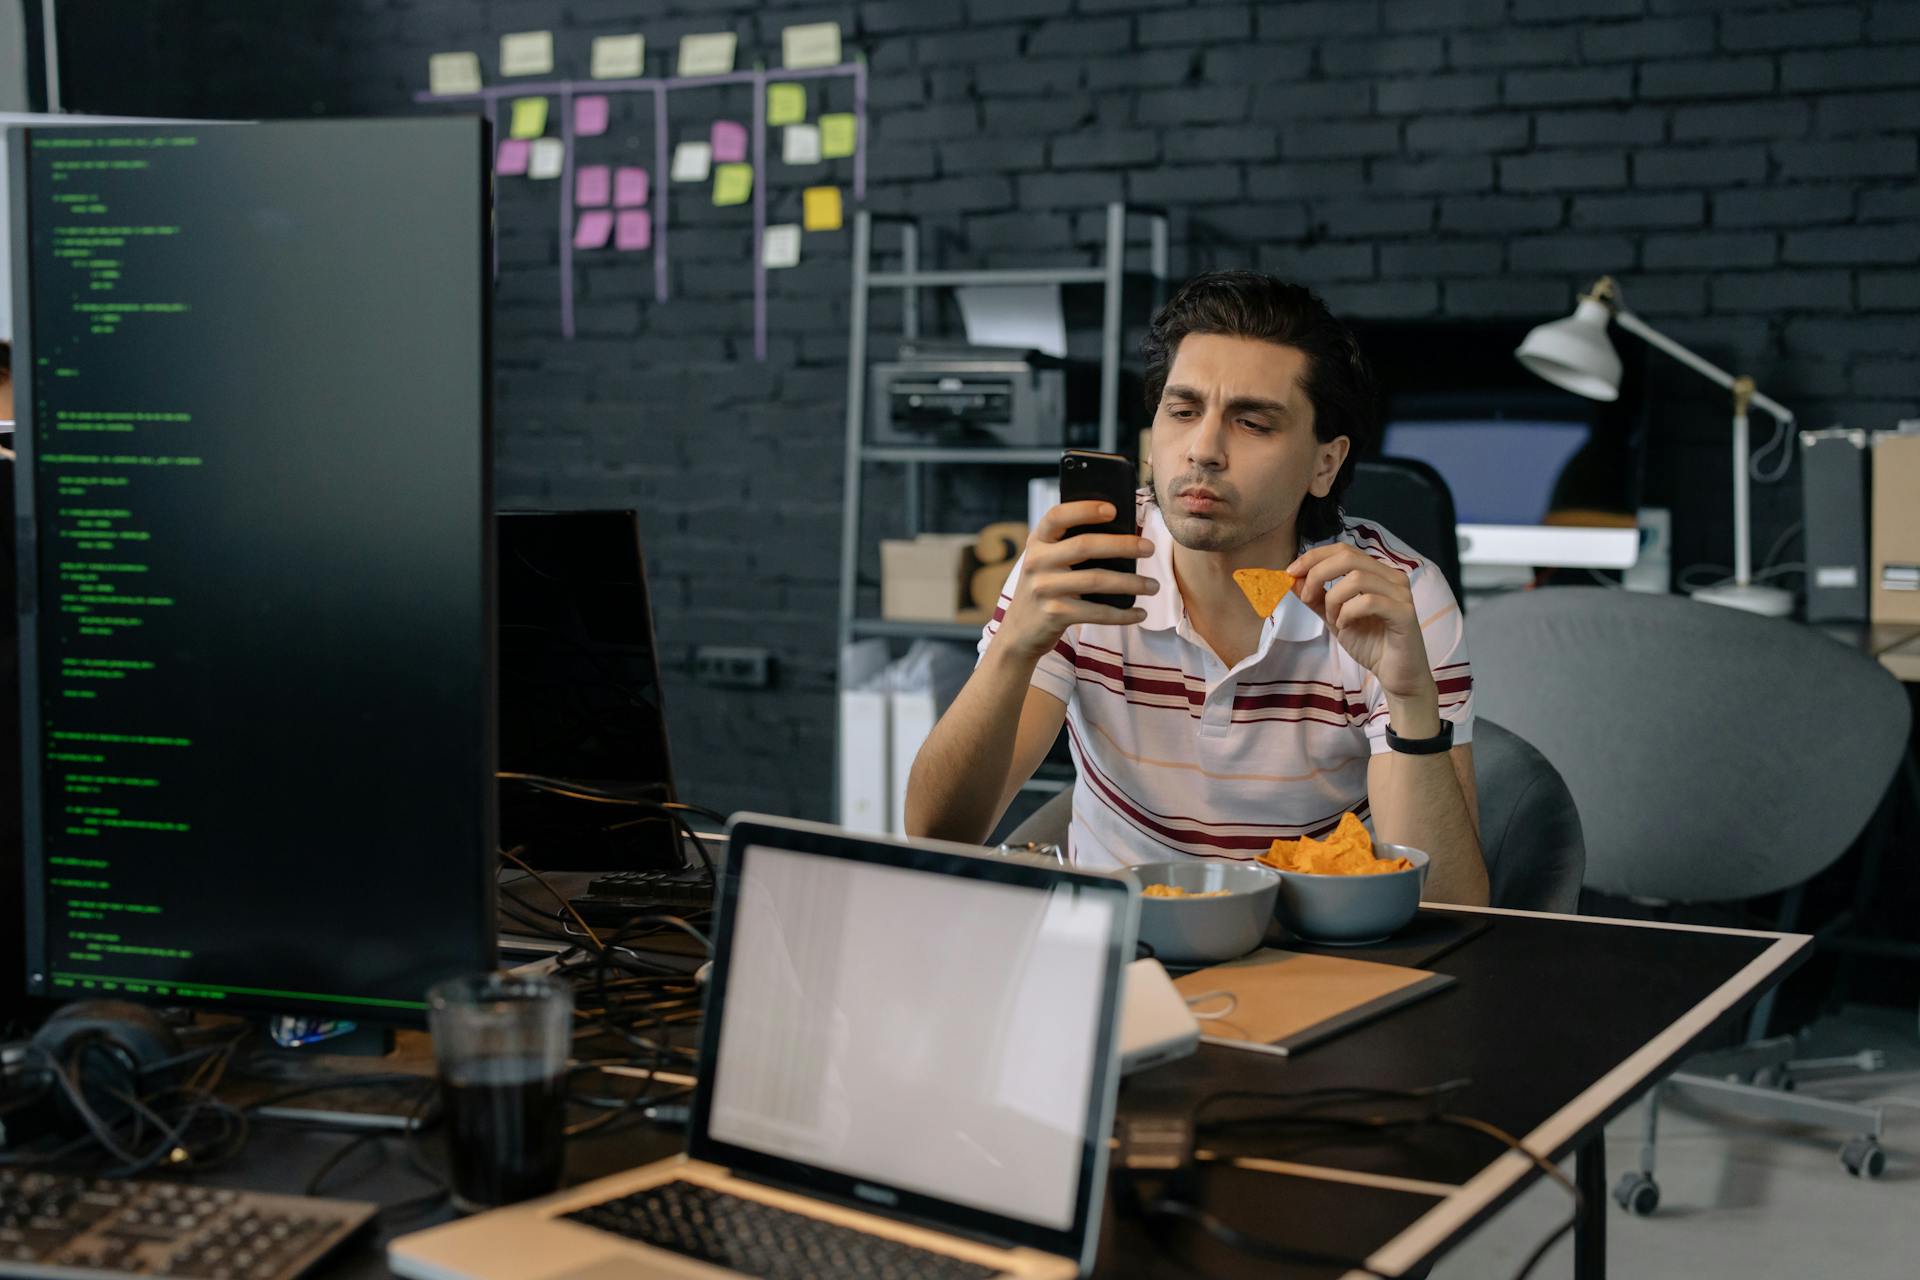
[1467,587,1908,902]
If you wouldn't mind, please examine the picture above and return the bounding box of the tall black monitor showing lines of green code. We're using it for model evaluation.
[10,119,495,1023]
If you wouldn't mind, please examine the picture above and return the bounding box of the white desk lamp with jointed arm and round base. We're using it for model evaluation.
[1513,276,1793,618]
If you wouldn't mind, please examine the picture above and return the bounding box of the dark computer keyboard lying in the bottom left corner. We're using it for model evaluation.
[0,1169,376,1280]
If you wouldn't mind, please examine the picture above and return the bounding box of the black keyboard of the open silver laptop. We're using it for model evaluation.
[566,1182,1000,1280]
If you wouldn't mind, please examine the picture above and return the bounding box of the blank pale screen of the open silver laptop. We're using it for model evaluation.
[707,829,1129,1251]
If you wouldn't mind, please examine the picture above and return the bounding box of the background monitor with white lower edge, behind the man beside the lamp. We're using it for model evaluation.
[1359,320,1645,568]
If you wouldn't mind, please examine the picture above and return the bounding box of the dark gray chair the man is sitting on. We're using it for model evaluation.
[1006,718,1586,912]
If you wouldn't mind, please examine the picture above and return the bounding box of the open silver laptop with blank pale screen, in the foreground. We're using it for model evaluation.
[388,814,1139,1280]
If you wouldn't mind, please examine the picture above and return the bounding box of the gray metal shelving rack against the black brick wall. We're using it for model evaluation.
[835,203,1167,817]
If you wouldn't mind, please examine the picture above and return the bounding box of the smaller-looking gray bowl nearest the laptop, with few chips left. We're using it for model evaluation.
[1129,862,1281,965]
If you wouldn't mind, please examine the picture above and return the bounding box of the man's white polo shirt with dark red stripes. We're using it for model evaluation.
[979,491,1473,867]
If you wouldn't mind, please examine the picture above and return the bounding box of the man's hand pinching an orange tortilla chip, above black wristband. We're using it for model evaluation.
[1286,543,1434,699]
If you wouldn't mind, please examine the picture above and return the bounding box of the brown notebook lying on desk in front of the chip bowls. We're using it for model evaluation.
[1173,948,1453,1057]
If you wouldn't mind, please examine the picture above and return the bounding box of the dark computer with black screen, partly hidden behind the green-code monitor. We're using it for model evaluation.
[497,510,684,871]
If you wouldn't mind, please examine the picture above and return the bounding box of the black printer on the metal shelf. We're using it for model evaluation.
[868,340,1100,449]
